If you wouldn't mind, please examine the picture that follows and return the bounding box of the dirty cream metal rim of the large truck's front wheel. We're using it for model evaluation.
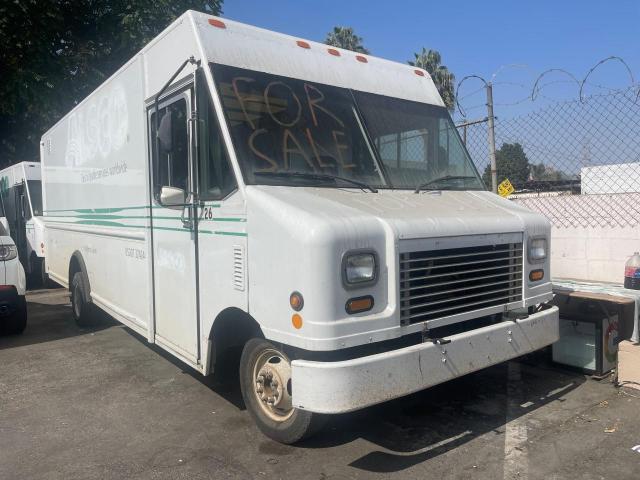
[253,348,294,422]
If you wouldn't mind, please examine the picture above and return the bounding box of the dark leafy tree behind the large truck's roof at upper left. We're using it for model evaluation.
[0,0,223,167]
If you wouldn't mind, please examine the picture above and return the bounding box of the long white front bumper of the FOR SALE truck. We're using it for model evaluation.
[291,307,559,413]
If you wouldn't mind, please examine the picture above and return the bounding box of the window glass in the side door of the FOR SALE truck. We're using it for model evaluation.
[149,98,189,195]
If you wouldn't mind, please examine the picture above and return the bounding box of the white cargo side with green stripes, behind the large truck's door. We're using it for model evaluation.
[41,57,151,334]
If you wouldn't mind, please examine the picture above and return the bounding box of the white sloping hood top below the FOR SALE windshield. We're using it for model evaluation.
[247,186,549,240]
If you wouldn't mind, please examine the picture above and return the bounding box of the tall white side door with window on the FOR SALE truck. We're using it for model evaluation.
[148,85,200,363]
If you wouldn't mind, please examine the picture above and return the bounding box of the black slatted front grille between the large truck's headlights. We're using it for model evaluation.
[400,242,522,324]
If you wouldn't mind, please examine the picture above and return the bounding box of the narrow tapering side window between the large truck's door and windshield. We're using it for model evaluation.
[198,73,237,200]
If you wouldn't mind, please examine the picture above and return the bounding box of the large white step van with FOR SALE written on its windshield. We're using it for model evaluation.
[42,12,558,443]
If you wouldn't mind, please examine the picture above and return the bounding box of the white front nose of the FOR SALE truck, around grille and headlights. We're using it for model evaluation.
[246,186,551,350]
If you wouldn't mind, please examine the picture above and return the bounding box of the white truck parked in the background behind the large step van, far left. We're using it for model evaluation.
[0,162,46,285]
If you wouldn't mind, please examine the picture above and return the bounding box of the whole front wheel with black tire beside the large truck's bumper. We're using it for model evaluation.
[240,338,324,445]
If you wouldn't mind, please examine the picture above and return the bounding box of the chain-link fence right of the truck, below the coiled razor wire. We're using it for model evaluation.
[458,86,640,227]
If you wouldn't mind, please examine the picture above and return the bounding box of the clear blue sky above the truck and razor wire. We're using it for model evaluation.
[223,0,640,116]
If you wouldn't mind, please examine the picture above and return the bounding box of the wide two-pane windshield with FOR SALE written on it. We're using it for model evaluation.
[212,64,484,190]
